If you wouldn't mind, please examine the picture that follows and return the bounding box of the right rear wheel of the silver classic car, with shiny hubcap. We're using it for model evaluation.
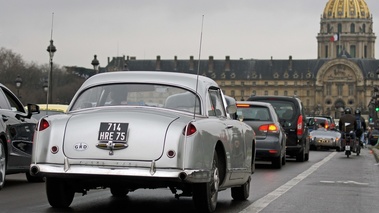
[193,152,220,212]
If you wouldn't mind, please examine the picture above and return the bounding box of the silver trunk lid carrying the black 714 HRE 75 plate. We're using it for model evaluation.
[64,108,178,161]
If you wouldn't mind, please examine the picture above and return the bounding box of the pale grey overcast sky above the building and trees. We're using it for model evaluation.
[0,0,379,68]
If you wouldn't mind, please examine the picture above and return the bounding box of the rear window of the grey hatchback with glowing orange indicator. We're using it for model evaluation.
[237,105,271,121]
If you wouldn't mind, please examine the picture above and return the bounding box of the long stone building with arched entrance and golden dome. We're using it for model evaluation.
[85,0,379,118]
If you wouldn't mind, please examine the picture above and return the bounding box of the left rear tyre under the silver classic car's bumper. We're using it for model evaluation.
[46,178,75,208]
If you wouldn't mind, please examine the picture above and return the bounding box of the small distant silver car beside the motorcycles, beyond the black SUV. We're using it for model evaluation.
[309,128,344,152]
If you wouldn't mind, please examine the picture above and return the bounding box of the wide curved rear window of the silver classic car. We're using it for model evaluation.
[71,84,200,114]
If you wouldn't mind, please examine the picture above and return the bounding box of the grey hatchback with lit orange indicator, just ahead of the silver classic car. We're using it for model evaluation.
[237,101,286,169]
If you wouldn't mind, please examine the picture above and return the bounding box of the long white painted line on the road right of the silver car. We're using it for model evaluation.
[240,152,337,213]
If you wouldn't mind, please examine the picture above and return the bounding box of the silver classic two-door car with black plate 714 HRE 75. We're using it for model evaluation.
[30,71,255,212]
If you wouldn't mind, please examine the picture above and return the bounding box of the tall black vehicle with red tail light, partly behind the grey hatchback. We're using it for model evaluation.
[247,96,309,162]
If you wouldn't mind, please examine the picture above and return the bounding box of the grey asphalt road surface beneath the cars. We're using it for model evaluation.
[0,149,379,213]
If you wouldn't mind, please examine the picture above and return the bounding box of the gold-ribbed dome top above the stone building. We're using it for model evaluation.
[323,0,370,19]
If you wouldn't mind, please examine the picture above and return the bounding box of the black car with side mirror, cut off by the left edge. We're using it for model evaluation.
[0,84,42,189]
